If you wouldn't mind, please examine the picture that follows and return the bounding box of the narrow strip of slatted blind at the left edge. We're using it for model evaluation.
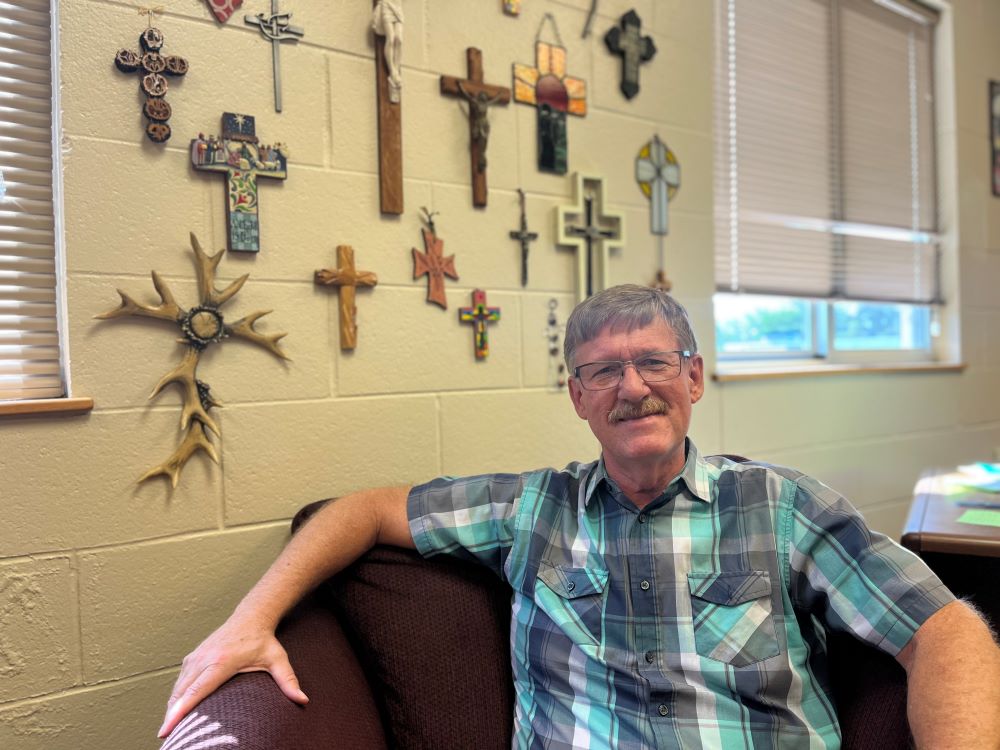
[0,0,66,400]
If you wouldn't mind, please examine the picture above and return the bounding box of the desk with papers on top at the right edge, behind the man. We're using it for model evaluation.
[900,470,1000,626]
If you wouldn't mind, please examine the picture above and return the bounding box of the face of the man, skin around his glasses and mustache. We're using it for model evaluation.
[569,318,705,475]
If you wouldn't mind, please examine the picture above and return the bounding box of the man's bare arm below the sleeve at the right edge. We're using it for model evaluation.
[896,601,1000,750]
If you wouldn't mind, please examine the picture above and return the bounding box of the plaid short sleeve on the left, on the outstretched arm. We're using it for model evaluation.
[406,474,524,577]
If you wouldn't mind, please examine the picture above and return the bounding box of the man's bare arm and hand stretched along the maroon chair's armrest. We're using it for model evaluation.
[158,487,414,737]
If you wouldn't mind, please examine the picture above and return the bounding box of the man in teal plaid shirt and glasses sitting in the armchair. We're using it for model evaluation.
[161,286,1000,750]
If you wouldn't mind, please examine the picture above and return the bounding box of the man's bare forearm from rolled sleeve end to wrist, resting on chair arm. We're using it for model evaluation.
[233,487,413,630]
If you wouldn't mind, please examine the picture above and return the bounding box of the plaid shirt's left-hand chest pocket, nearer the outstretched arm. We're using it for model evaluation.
[535,561,608,647]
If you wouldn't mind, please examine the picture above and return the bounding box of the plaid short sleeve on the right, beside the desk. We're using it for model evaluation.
[786,476,955,656]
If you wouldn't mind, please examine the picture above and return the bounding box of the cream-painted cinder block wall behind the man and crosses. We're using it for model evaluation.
[0,0,1000,750]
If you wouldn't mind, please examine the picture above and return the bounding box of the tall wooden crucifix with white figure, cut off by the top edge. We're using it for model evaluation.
[372,0,403,214]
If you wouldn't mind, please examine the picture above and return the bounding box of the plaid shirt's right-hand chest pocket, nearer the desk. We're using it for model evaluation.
[688,570,781,667]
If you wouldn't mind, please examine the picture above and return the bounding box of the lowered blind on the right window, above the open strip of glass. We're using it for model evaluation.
[715,0,941,303]
